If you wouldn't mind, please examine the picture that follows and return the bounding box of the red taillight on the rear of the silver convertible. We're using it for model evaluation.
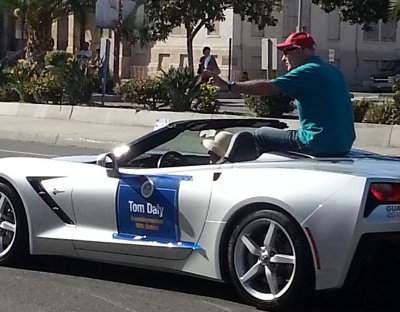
[364,183,400,217]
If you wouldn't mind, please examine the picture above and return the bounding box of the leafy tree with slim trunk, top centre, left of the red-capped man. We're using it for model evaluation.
[145,0,281,71]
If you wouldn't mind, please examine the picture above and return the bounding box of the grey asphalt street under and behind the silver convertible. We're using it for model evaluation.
[0,140,400,312]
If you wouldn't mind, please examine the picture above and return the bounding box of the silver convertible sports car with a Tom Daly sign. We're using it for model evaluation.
[0,119,400,310]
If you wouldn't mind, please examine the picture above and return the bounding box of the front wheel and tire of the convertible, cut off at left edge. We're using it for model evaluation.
[0,183,29,265]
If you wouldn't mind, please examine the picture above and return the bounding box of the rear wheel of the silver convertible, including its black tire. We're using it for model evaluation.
[227,210,315,311]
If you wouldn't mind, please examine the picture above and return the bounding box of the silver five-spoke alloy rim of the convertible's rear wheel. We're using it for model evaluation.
[233,218,296,302]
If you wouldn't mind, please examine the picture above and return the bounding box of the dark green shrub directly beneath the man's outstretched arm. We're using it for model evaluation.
[244,95,294,118]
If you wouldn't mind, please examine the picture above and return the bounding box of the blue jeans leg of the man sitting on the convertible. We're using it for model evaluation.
[254,127,305,153]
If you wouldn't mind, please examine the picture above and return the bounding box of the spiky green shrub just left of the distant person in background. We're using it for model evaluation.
[160,67,200,112]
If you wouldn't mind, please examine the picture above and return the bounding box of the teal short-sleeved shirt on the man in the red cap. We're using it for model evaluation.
[271,56,356,156]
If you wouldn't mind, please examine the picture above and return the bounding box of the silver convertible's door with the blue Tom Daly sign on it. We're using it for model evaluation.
[72,166,216,259]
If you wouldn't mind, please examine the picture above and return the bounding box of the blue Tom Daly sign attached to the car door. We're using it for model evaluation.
[115,175,188,243]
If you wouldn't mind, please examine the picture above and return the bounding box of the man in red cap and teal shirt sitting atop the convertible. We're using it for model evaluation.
[205,32,355,156]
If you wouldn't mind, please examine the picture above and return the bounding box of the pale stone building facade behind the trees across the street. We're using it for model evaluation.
[0,0,400,87]
